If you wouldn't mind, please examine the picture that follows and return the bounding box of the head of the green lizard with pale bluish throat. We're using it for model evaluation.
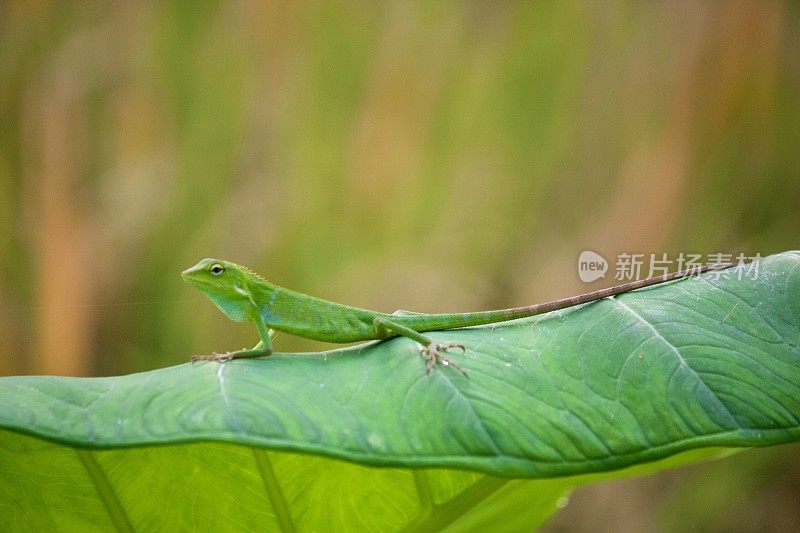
[181,259,259,322]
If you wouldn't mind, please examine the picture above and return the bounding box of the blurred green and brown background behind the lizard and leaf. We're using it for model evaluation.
[0,0,800,531]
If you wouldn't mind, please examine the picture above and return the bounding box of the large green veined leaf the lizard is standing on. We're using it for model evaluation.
[0,252,800,530]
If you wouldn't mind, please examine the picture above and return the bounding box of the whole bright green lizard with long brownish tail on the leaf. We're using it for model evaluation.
[181,259,733,376]
